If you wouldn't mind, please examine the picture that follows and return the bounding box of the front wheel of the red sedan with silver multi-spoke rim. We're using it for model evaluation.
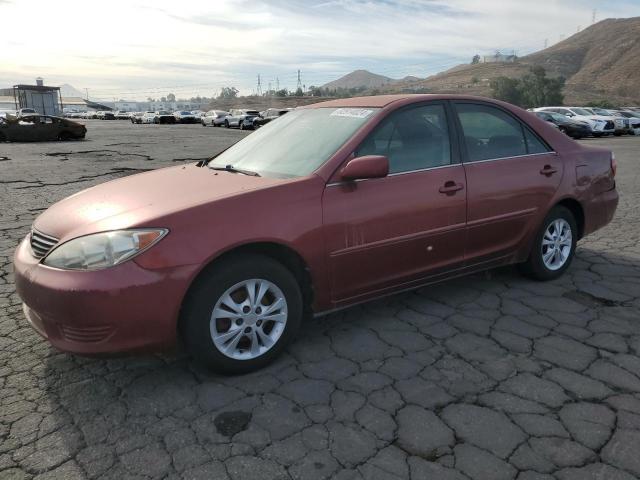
[180,254,303,375]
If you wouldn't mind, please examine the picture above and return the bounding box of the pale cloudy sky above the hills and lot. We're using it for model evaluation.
[0,0,640,100]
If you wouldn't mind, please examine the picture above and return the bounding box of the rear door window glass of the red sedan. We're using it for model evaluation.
[456,103,549,162]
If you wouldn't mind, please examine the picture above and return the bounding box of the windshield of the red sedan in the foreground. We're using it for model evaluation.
[209,108,379,178]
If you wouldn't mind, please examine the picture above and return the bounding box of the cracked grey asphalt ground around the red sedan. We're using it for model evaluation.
[0,121,640,480]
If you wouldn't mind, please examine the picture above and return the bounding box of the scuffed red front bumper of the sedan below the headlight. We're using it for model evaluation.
[13,237,195,354]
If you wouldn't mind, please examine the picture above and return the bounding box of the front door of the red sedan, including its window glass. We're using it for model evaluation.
[323,103,466,305]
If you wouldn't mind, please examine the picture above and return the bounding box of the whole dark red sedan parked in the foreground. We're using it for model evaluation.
[14,95,618,373]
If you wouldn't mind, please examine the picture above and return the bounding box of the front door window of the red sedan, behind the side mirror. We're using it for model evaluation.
[356,105,451,173]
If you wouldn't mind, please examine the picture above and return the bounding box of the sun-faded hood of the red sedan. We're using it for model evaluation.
[34,164,288,240]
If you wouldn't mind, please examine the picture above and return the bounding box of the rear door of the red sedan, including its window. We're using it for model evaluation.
[453,101,563,265]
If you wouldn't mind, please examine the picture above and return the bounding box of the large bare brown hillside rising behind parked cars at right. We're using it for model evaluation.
[385,17,640,104]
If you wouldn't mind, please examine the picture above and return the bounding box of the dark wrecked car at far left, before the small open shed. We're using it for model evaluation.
[0,114,87,142]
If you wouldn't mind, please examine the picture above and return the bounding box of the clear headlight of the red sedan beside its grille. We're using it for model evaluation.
[42,228,168,270]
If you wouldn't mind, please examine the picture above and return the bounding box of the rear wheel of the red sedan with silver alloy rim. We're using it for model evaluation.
[520,205,578,281]
